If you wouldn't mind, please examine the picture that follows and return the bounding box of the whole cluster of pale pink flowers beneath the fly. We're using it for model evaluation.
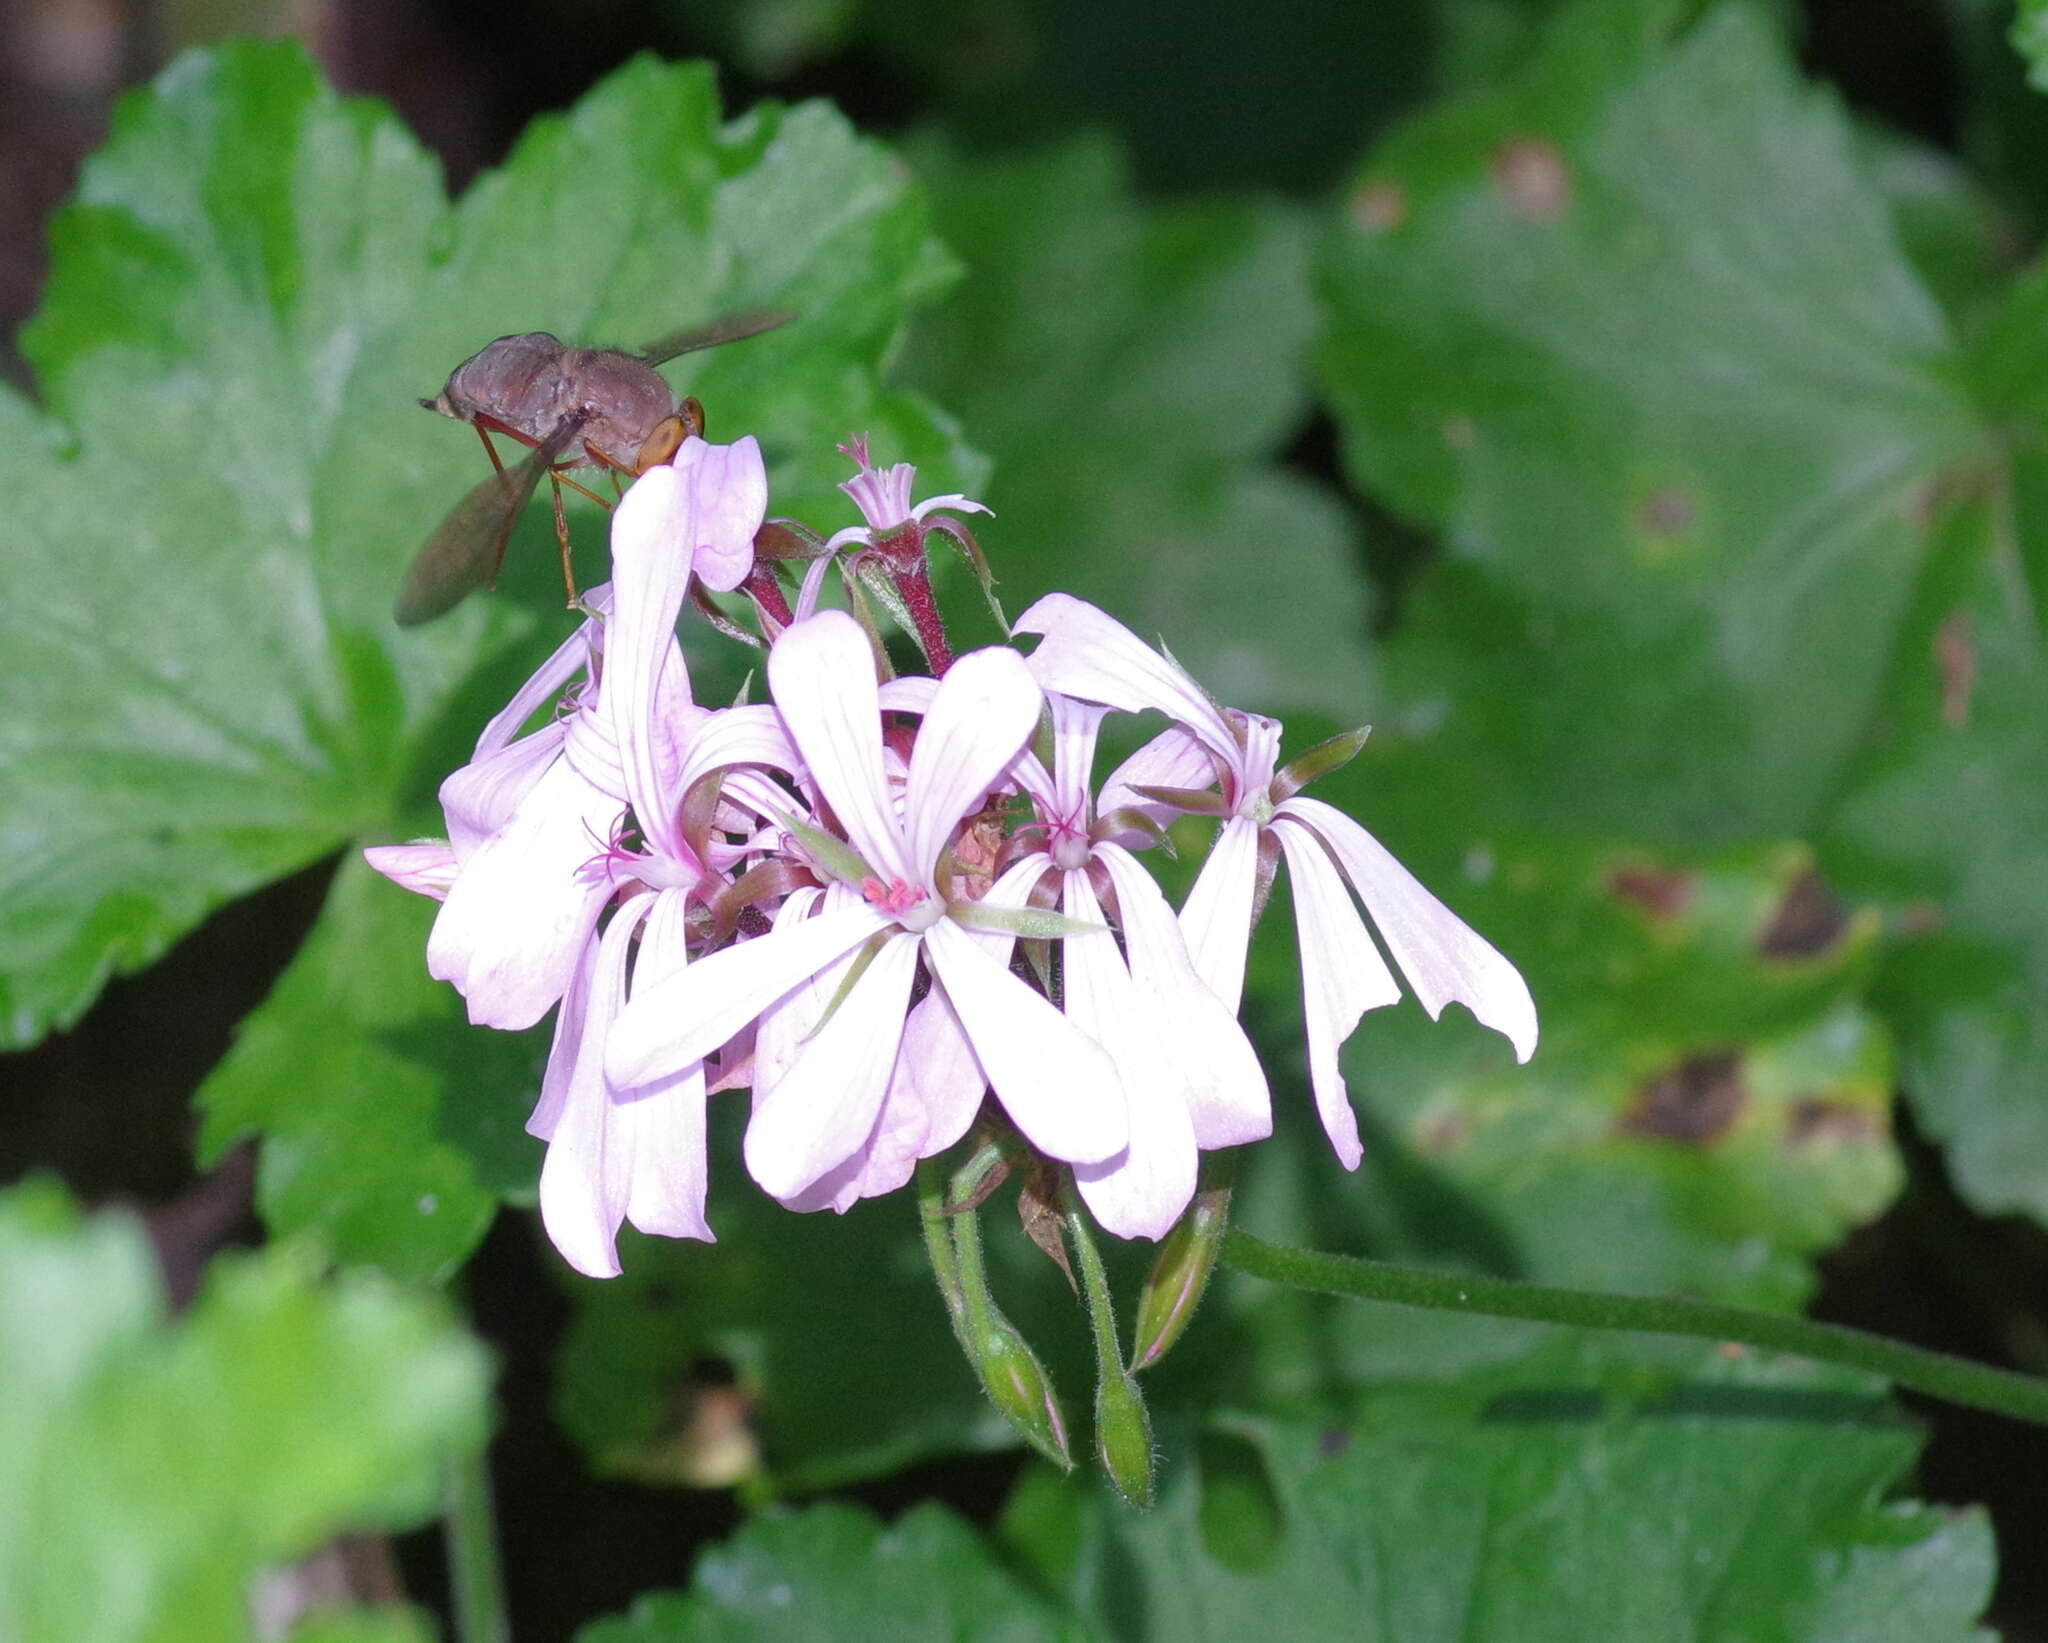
[367,438,1536,1276]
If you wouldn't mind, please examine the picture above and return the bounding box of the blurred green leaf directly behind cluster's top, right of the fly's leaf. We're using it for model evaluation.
[909,141,1366,723]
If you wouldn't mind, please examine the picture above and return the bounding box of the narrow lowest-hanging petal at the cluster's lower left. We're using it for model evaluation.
[541,895,653,1278]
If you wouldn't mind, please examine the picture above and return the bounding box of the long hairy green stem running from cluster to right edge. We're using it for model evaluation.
[1223,1227,2048,1426]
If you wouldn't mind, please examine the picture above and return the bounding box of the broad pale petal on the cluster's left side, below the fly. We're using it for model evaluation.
[426,760,618,1030]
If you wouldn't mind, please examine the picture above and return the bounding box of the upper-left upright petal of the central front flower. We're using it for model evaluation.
[768,610,918,883]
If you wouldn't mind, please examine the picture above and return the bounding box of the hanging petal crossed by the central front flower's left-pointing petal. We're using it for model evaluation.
[612,889,715,1244]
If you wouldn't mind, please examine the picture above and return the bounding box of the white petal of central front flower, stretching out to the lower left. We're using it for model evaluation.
[604,903,883,1086]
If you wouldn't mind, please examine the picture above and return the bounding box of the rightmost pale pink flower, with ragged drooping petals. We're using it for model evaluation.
[1016,594,1536,1168]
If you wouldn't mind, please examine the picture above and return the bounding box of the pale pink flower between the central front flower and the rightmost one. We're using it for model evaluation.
[1016,692,1272,1237]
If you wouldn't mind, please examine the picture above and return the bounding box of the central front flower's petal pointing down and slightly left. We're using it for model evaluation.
[745,932,918,1198]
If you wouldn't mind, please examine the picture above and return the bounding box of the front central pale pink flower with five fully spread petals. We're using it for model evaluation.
[606,610,1126,1203]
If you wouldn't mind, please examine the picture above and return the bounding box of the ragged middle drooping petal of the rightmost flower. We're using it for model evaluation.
[1274,817,1401,1170]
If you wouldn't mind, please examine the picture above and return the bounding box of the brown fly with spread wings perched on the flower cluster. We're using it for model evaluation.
[393,309,795,627]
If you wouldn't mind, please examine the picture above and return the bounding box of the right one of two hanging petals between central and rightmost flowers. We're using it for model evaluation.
[1096,844,1274,1147]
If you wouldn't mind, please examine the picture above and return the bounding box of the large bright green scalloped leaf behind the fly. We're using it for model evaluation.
[0,43,979,1043]
